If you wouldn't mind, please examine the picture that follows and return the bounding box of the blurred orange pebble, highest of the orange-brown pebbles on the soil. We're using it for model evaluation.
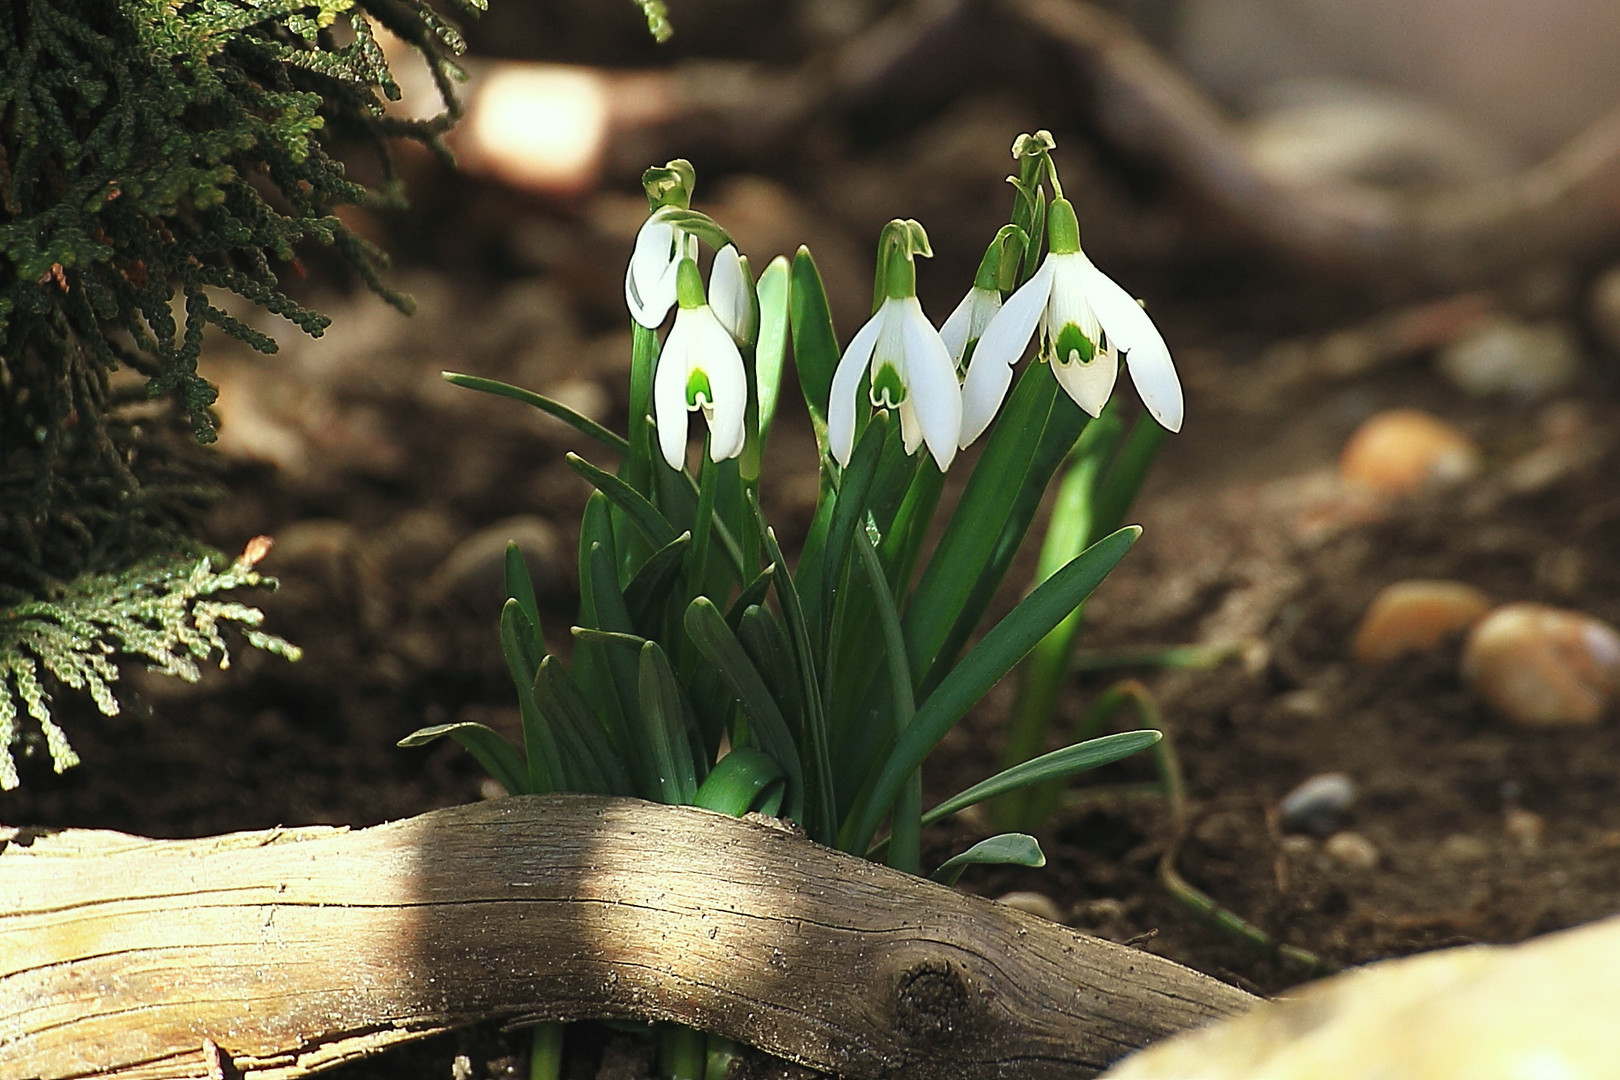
[1338,408,1479,495]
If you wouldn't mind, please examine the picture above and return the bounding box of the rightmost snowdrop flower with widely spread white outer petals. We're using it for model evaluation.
[961,198,1183,447]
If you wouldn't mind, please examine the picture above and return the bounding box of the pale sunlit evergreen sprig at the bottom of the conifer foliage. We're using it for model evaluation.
[0,554,298,790]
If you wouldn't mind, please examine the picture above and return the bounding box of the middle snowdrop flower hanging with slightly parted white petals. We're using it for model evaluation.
[826,234,962,471]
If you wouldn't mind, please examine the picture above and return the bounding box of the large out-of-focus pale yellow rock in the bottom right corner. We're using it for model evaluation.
[1103,918,1620,1080]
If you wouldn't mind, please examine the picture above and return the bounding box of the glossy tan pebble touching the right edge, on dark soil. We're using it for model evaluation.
[1463,604,1620,725]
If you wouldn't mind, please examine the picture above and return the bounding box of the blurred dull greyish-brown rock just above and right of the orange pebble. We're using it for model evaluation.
[1439,317,1581,402]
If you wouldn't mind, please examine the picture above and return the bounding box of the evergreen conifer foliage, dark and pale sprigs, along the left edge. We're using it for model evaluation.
[0,0,484,785]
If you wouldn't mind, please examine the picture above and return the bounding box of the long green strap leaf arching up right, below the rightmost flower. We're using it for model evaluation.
[839,526,1142,852]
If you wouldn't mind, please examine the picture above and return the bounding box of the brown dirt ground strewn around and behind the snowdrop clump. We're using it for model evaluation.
[0,4,1620,1077]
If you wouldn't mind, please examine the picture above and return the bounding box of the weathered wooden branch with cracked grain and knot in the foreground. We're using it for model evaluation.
[0,795,1252,1080]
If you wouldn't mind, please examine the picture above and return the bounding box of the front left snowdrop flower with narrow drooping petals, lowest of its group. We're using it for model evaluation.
[653,257,748,470]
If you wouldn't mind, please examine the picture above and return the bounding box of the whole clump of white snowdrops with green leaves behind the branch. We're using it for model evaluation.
[403,131,1183,1077]
